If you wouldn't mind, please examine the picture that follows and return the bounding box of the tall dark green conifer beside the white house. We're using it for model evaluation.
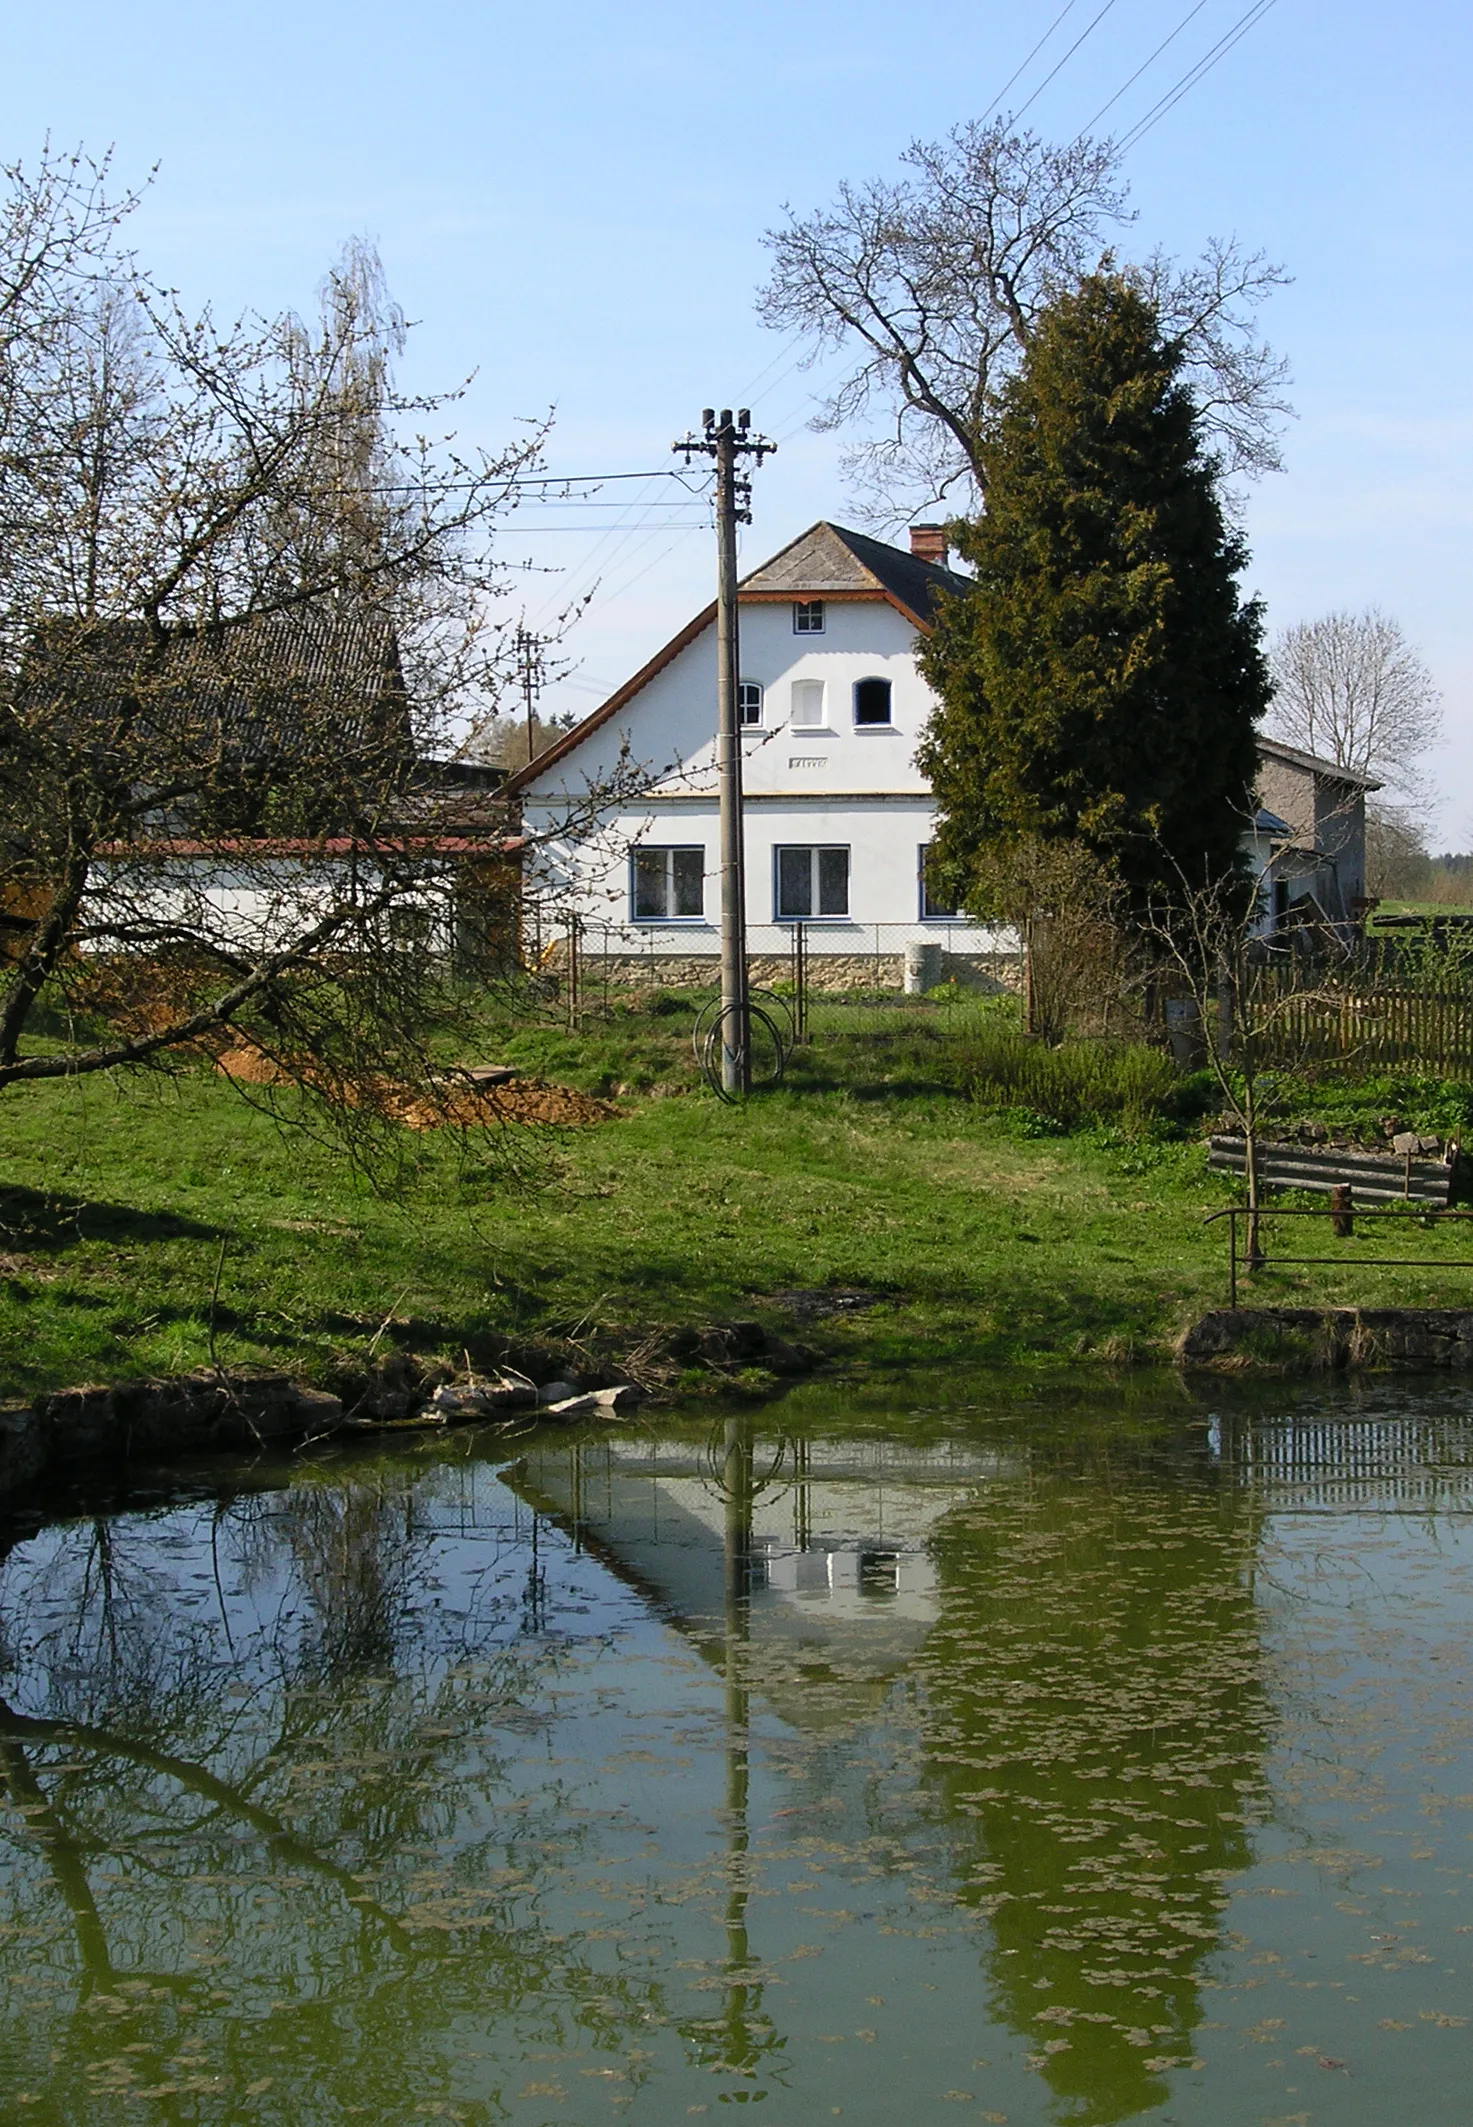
[922,272,1269,912]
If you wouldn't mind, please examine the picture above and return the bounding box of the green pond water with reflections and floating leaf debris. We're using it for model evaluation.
[0,1383,1473,2127]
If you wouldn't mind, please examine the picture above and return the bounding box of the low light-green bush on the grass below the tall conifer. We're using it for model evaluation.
[961,1025,1184,1129]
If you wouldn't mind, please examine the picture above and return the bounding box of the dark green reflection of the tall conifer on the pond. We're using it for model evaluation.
[922,1466,1269,2123]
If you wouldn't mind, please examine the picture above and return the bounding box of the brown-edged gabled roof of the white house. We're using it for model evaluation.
[502,519,969,798]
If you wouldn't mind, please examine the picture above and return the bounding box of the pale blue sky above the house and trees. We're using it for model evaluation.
[0,0,1473,829]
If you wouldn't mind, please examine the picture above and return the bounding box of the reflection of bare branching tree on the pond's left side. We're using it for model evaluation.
[0,1478,671,2127]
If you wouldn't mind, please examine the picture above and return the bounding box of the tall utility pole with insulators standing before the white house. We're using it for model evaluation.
[672,406,778,1095]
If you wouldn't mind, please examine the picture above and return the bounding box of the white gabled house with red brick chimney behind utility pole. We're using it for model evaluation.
[506,523,1016,987]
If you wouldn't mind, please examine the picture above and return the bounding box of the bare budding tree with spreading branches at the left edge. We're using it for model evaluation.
[0,164,633,1174]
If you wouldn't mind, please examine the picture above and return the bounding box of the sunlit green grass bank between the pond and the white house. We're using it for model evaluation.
[0,1000,1473,1397]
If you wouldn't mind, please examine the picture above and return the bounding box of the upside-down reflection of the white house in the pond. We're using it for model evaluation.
[504,1431,1020,1729]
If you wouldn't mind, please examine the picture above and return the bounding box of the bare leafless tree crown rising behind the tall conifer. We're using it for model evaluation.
[759,117,1286,521]
